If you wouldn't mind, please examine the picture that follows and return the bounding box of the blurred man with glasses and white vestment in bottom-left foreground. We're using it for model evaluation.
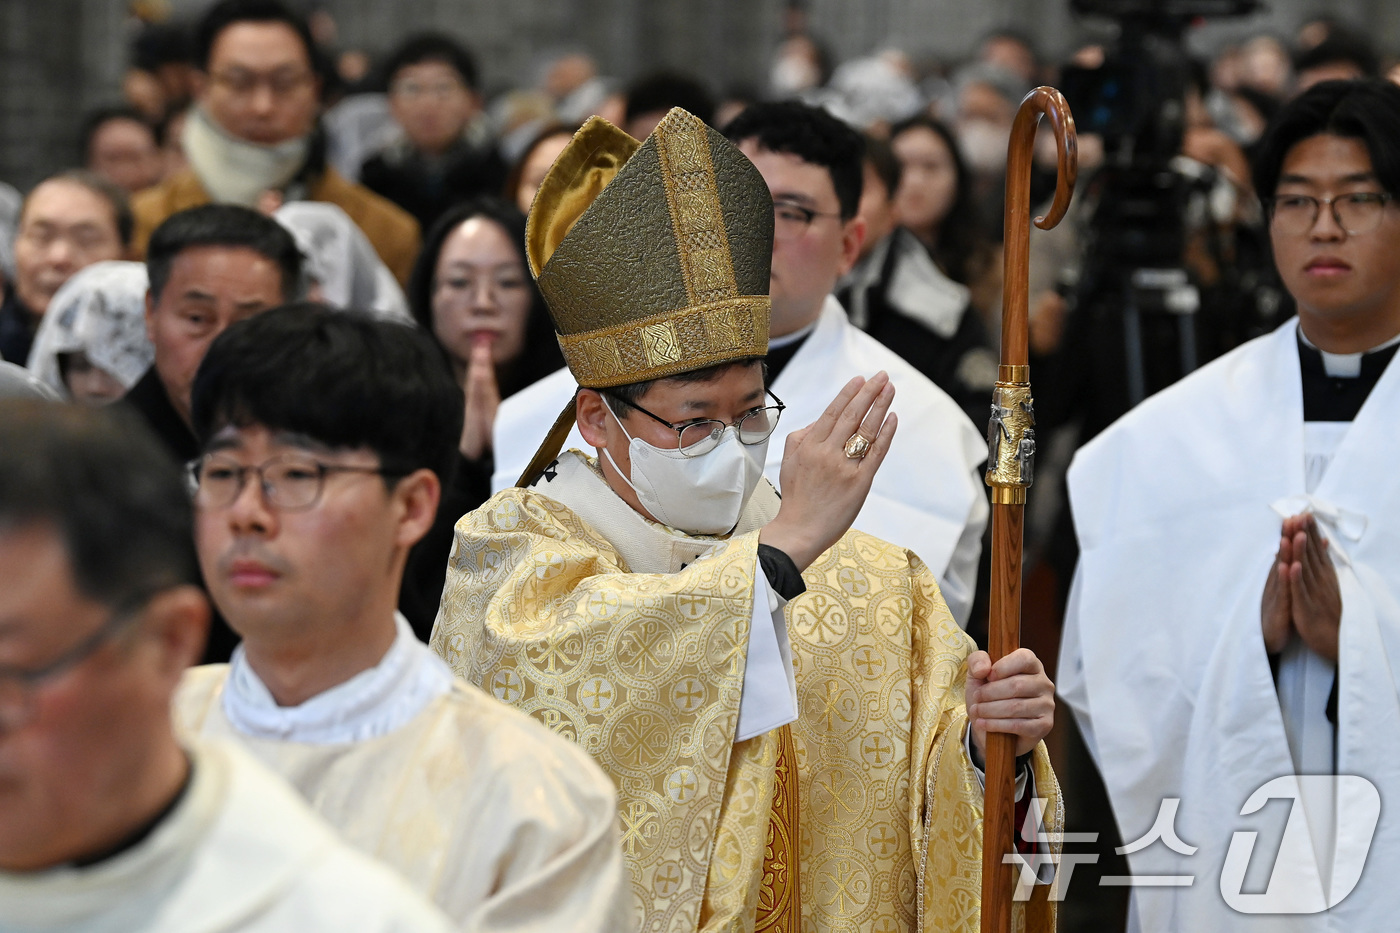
[0,399,451,933]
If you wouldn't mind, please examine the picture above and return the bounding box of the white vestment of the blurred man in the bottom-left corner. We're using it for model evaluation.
[0,740,452,933]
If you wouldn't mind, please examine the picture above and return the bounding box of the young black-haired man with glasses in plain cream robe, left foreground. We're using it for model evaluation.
[175,304,627,933]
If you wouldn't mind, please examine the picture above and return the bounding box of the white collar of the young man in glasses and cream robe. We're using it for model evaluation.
[223,612,454,745]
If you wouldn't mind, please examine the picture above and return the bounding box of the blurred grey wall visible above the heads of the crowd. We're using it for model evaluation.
[0,0,1400,188]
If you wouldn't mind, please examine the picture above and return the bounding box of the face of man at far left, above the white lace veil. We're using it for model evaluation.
[14,178,126,319]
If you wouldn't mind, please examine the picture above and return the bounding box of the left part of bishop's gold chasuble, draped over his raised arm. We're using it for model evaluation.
[431,488,777,932]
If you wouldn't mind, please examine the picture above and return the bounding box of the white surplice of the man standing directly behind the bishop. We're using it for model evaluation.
[491,296,990,626]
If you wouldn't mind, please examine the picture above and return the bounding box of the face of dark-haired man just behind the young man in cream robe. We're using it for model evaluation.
[146,247,288,423]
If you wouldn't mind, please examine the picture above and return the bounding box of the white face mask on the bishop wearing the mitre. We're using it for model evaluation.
[603,405,769,535]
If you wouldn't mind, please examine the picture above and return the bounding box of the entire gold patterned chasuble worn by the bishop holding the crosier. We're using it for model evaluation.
[431,488,1058,933]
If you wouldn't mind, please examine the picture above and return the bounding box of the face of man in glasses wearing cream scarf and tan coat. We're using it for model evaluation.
[199,22,321,146]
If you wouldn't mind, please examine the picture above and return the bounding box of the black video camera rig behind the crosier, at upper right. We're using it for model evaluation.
[1060,0,1282,413]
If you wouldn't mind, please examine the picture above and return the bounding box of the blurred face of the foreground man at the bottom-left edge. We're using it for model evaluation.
[0,524,183,871]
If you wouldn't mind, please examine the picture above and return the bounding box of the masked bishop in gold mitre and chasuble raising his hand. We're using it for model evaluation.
[431,109,1057,932]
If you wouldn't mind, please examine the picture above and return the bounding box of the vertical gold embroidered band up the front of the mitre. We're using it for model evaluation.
[654,111,739,304]
